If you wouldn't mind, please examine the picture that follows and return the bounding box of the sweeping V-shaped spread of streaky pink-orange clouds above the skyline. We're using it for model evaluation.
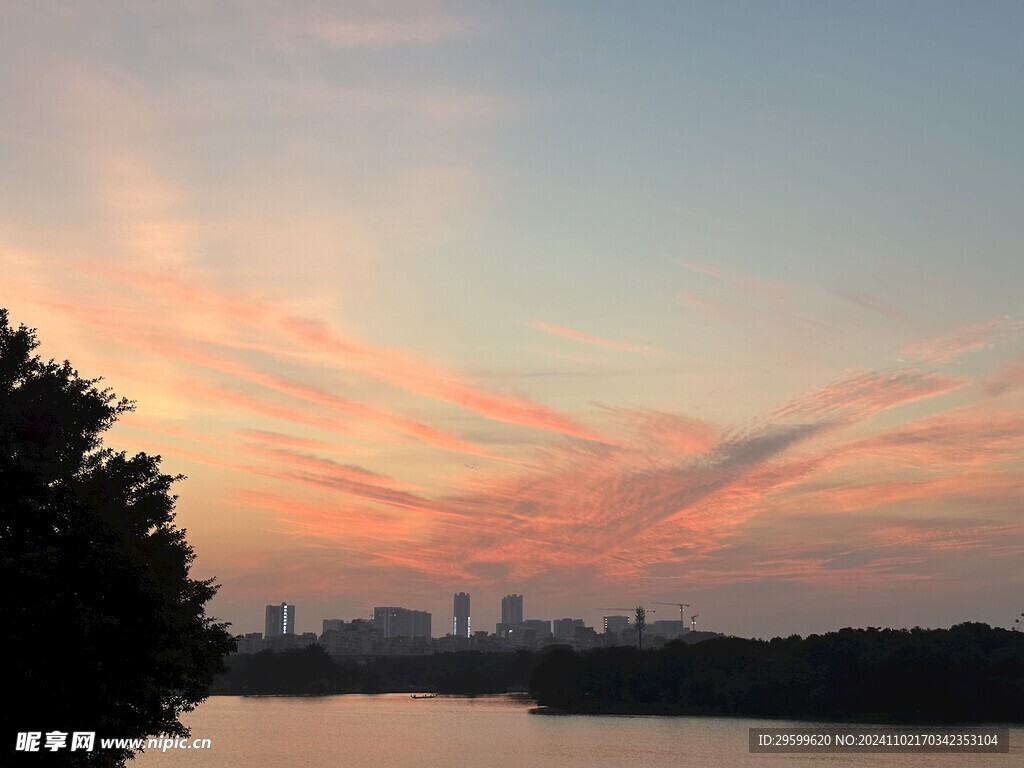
[18,259,1024,606]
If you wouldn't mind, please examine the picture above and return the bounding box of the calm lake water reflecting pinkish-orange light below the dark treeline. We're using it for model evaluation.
[130,694,1024,768]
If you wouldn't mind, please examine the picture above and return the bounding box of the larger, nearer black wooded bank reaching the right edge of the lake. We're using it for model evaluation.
[529,624,1024,722]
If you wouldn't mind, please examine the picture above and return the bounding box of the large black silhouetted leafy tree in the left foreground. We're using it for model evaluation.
[0,309,234,766]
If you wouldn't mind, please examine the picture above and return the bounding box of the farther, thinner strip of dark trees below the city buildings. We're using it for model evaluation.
[210,645,540,695]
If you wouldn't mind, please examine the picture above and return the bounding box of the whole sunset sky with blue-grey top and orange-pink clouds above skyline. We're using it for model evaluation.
[0,0,1024,637]
